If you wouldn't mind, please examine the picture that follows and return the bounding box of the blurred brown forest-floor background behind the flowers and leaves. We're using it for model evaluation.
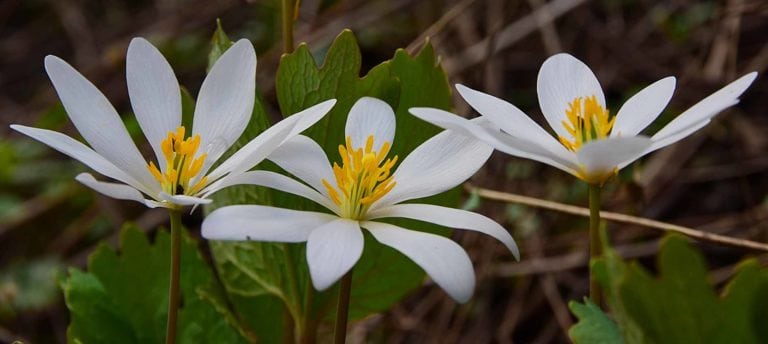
[0,0,768,343]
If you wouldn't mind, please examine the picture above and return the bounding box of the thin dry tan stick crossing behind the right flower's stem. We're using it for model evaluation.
[466,185,768,252]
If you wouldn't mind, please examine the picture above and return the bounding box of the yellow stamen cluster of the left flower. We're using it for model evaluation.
[147,127,207,195]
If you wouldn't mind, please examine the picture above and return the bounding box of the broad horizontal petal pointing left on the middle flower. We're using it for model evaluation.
[202,205,337,242]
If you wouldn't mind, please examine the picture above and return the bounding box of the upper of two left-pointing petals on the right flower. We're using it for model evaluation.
[456,85,563,151]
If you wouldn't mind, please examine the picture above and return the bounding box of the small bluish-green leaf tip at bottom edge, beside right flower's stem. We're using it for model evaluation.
[568,298,624,344]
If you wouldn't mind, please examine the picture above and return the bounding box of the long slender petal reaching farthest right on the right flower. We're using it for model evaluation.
[652,72,757,149]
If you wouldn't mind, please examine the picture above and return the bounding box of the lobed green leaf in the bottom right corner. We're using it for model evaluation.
[593,235,768,343]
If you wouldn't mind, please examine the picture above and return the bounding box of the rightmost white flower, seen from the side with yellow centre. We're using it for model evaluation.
[410,54,757,184]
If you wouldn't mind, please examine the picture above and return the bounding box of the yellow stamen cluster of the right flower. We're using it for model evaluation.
[558,95,616,152]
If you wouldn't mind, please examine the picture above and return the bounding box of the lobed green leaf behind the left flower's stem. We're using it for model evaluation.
[61,226,246,343]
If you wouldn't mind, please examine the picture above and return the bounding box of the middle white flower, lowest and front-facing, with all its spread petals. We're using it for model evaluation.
[202,98,518,302]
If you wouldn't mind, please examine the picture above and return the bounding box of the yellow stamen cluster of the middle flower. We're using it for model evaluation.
[323,135,397,220]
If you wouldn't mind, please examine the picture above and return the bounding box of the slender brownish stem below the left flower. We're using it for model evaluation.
[165,209,181,344]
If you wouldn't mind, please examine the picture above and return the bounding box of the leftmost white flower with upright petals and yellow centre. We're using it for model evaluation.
[11,38,335,208]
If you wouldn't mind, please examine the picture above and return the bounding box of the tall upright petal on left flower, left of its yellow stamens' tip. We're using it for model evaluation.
[130,38,181,167]
